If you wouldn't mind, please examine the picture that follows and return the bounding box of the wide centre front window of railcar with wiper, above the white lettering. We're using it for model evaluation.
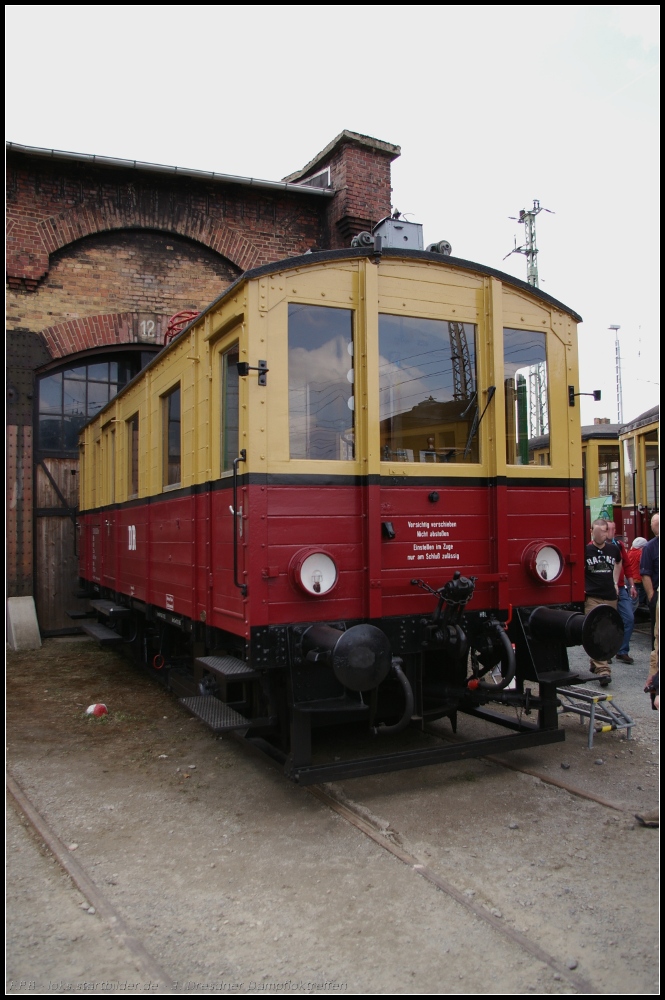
[379,314,480,463]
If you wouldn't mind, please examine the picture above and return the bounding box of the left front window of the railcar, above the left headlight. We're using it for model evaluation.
[289,303,354,461]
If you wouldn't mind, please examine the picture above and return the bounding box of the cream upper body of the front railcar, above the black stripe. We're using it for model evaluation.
[82,244,580,490]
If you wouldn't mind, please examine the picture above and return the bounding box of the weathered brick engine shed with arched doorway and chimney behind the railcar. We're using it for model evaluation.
[6,131,400,634]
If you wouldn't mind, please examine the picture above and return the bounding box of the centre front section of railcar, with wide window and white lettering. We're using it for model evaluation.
[376,309,492,615]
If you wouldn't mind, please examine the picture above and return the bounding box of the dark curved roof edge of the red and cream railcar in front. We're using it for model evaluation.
[85,247,582,426]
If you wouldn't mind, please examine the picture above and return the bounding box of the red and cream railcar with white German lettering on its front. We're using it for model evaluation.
[79,240,614,782]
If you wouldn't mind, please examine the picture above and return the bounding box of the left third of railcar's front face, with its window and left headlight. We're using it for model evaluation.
[258,292,368,625]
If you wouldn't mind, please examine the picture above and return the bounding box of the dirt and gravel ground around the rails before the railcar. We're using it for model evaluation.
[6,634,659,995]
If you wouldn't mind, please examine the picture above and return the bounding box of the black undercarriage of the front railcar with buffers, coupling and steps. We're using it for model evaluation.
[76,573,623,785]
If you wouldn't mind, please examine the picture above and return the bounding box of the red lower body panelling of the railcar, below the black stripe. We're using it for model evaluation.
[79,481,584,636]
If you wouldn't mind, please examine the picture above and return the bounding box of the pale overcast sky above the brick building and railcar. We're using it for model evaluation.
[5,4,660,423]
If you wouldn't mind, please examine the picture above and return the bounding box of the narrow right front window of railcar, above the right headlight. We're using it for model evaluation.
[503,329,550,465]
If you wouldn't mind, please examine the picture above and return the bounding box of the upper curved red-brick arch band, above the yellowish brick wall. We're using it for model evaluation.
[7,199,262,290]
